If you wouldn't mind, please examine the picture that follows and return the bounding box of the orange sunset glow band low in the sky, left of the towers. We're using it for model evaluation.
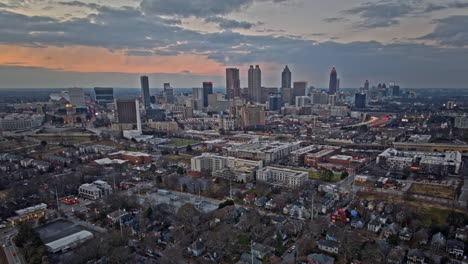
[0,45,221,75]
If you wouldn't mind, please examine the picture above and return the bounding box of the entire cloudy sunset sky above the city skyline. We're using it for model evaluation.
[0,0,468,88]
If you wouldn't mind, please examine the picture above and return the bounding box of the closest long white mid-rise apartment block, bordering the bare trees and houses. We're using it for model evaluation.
[257,167,309,188]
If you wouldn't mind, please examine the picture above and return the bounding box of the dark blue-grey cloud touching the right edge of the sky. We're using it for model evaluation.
[419,16,468,47]
